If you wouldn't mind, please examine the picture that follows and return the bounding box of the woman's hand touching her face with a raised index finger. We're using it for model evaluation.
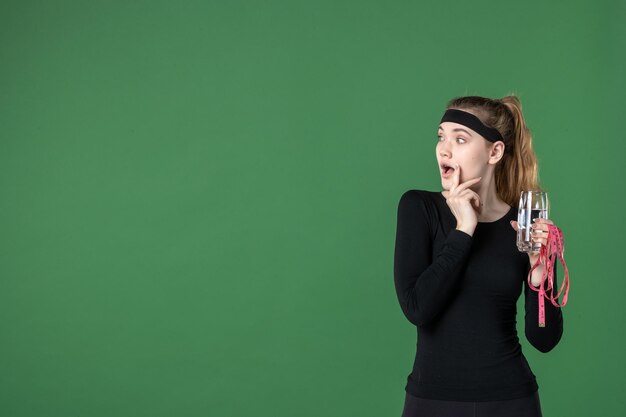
[446,165,482,236]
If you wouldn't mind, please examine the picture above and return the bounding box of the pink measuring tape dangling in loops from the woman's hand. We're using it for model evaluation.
[528,224,569,327]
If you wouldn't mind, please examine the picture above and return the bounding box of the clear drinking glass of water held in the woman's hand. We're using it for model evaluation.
[517,191,548,252]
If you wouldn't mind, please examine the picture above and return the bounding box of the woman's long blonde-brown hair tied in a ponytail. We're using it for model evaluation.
[446,95,542,207]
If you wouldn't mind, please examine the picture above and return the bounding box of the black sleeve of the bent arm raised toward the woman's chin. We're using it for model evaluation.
[394,190,472,326]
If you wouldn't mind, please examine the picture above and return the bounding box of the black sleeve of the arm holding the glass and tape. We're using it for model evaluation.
[524,259,563,353]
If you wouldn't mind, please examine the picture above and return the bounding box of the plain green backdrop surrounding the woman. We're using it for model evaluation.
[0,0,626,417]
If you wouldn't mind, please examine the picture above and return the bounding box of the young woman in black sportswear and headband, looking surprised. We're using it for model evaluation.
[394,96,563,417]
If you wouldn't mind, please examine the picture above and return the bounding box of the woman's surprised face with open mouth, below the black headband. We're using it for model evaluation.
[436,122,490,190]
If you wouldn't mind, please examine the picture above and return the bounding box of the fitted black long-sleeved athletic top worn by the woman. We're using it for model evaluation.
[394,190,563,401]
